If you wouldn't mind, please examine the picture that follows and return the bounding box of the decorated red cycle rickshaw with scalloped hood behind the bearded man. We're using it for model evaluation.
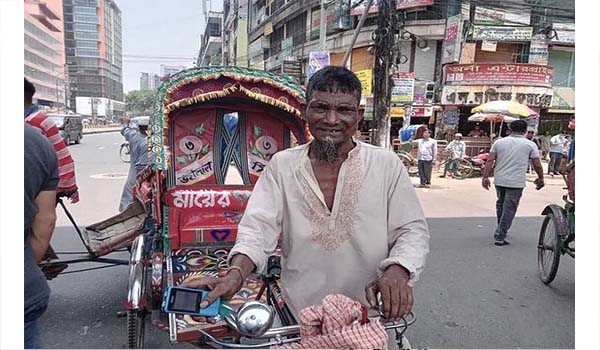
[125,67,414,348]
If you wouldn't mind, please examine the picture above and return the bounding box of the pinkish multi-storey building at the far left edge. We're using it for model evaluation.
[24,0,66,108]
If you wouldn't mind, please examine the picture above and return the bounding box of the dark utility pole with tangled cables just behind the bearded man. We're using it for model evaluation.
[371,0,398,147]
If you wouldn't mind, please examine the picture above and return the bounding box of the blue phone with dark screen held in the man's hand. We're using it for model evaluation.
[162,287,221,317]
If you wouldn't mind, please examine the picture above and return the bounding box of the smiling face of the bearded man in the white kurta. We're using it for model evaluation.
[305,91,363,145]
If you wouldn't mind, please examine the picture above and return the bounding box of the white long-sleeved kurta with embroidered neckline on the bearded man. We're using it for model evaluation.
[229,141,429,316]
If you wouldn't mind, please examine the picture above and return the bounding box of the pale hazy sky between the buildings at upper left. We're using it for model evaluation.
[116,0,223,93]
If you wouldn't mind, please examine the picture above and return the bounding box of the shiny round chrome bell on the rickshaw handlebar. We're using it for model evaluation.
[236,301,275,338]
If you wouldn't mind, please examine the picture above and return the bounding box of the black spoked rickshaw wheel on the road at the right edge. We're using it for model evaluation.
[538,213,562,284]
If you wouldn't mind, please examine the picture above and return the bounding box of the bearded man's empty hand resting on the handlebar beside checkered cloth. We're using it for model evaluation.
[365,265,413,320]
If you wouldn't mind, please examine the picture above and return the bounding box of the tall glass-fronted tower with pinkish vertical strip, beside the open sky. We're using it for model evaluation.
[63,0,125,117]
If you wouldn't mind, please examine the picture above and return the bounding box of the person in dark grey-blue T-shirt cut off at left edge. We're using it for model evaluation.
[23,124,59,349]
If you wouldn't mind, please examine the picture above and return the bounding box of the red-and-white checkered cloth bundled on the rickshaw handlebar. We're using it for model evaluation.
[280,294,388,349]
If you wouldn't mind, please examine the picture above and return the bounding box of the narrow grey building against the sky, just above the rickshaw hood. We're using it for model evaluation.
[196,11,223,66]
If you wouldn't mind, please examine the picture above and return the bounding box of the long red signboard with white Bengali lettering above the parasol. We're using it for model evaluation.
[444,63,554,87]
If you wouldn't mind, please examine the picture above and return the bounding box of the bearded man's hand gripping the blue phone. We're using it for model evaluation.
[181,270,244,308]
